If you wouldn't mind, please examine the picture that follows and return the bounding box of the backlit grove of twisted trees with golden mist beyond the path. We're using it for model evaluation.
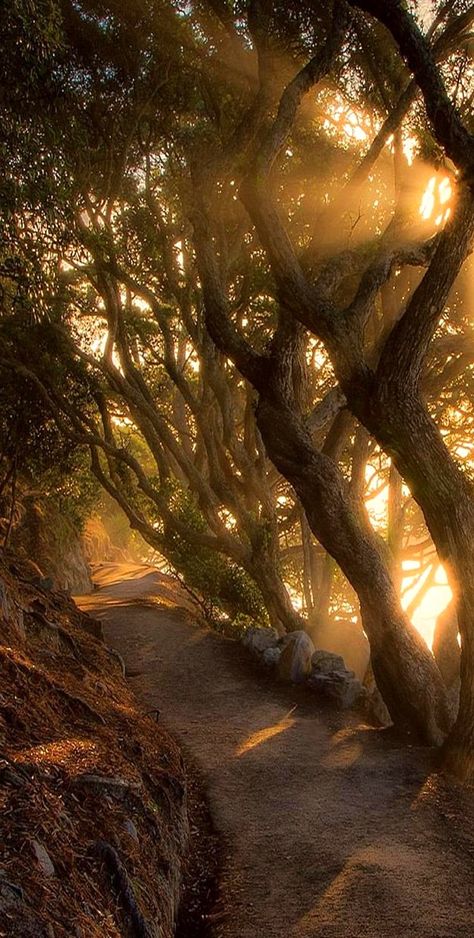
[0,0,474,775]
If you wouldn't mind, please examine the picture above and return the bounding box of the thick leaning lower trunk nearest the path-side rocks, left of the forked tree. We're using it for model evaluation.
[257,393,452,745]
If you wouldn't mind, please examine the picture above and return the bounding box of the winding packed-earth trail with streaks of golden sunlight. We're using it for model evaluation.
[80,564,474,938]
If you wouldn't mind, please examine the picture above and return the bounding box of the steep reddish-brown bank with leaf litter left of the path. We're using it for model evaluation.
[0,563,193,938]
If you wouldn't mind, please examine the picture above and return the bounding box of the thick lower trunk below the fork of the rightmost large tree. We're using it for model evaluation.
[349,374,474,777]
